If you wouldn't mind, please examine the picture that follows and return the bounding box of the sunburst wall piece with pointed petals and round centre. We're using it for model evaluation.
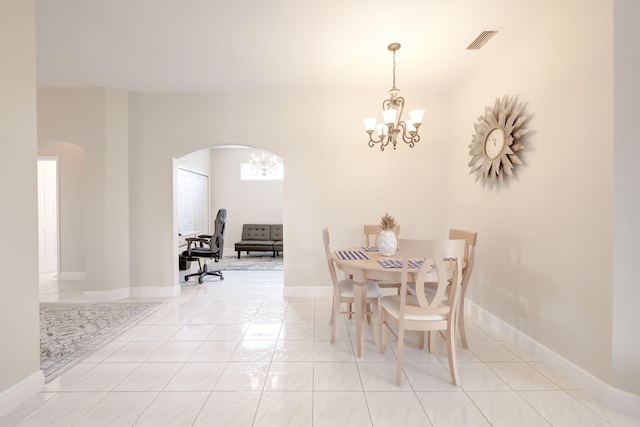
[469,95,529,187]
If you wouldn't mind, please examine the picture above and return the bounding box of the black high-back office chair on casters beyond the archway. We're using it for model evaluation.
[182,209,227,283]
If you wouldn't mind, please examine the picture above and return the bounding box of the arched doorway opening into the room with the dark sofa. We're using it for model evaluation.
[174,145,284,283]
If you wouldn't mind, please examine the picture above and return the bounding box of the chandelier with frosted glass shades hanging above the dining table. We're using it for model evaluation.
[364,43,424,151]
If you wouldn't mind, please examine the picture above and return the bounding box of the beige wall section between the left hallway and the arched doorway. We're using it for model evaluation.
[37,88,130,299]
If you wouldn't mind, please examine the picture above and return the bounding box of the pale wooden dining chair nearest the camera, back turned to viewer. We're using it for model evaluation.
[380,239,465,385]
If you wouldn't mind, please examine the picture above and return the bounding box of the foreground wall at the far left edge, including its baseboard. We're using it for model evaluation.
[0,0,44,404]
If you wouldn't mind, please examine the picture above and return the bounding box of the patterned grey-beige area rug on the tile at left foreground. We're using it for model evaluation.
[40,303,160,382]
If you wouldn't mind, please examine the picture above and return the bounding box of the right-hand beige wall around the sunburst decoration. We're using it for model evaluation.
[447,0,616,392]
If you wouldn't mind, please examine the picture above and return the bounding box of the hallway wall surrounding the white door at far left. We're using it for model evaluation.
[38,141,85,277]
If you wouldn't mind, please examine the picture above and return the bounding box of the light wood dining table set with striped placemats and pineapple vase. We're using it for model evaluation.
[332,246,455,357]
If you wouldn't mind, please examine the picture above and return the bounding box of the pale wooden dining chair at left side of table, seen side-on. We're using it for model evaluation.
[322,227,381,344]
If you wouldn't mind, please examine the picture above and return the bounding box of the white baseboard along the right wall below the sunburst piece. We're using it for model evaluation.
[465,300,640,418]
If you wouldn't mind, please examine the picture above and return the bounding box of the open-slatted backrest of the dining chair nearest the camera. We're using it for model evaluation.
[399,239,465,317]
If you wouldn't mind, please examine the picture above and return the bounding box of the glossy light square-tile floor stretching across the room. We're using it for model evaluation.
[0,271,640,427]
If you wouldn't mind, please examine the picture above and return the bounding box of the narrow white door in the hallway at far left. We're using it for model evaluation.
[38,158,58,274]
